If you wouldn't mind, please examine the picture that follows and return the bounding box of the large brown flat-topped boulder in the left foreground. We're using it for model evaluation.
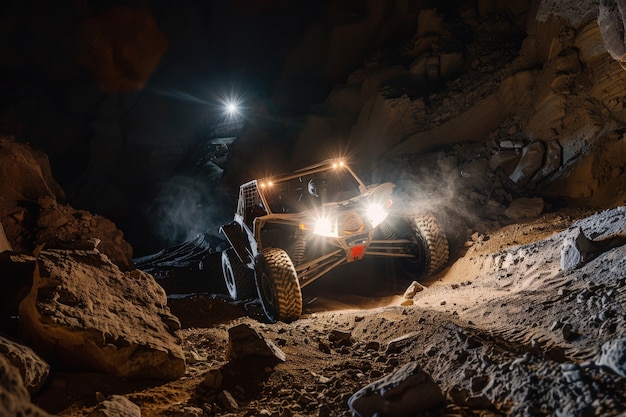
[19,249,185,380]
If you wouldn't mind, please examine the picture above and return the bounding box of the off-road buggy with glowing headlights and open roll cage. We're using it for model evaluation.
[220,160,448,321]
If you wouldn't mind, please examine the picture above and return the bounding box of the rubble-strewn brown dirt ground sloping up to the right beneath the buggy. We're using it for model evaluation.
[34,202,626,417]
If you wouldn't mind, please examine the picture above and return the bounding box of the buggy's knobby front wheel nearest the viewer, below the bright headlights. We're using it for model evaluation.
[256,248,302,322]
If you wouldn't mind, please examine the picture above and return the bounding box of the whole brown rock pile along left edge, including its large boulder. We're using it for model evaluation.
[0,138,186,410]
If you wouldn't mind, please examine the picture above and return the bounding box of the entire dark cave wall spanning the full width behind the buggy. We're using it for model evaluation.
[2,0,626,251]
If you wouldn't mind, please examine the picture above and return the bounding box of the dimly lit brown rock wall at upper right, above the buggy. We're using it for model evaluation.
[294,1,626,206]
